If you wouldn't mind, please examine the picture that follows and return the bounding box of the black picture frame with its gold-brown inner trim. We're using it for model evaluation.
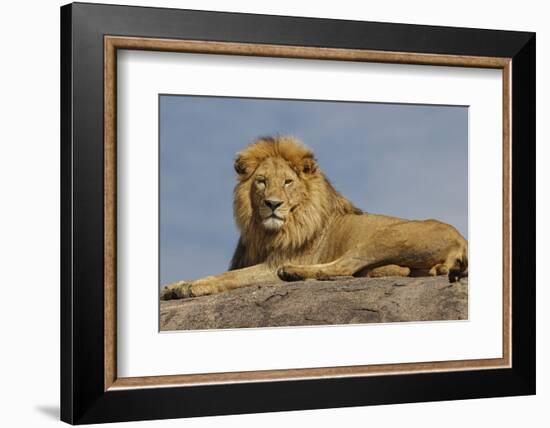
[61,3,536,424]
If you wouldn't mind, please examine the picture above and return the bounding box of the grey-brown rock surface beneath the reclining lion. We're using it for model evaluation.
[160,276,468,331]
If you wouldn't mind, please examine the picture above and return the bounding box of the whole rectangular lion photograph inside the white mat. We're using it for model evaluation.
[159,94,468,331]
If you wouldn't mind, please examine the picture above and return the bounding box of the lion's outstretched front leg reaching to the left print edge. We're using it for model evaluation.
[160,264,280,300]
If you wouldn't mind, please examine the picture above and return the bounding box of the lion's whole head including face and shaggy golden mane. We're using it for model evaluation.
[232,136,361,267]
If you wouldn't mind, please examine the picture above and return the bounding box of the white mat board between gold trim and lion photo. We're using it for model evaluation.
[117,51,502,377]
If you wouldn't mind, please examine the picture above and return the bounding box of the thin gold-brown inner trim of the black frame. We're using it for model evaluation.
[104,36,512,391]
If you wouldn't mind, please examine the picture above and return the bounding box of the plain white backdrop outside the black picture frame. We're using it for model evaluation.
[0,0,550,428]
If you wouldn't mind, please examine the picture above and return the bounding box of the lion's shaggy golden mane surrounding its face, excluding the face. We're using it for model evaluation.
[230,136,362,269]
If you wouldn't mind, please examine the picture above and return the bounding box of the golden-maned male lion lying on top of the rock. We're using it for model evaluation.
[161,136,468,300]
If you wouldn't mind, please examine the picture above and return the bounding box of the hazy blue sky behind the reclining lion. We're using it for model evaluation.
[160,95,468,285]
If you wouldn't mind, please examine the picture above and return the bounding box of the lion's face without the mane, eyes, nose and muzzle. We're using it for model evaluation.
[250,158,306,232]
